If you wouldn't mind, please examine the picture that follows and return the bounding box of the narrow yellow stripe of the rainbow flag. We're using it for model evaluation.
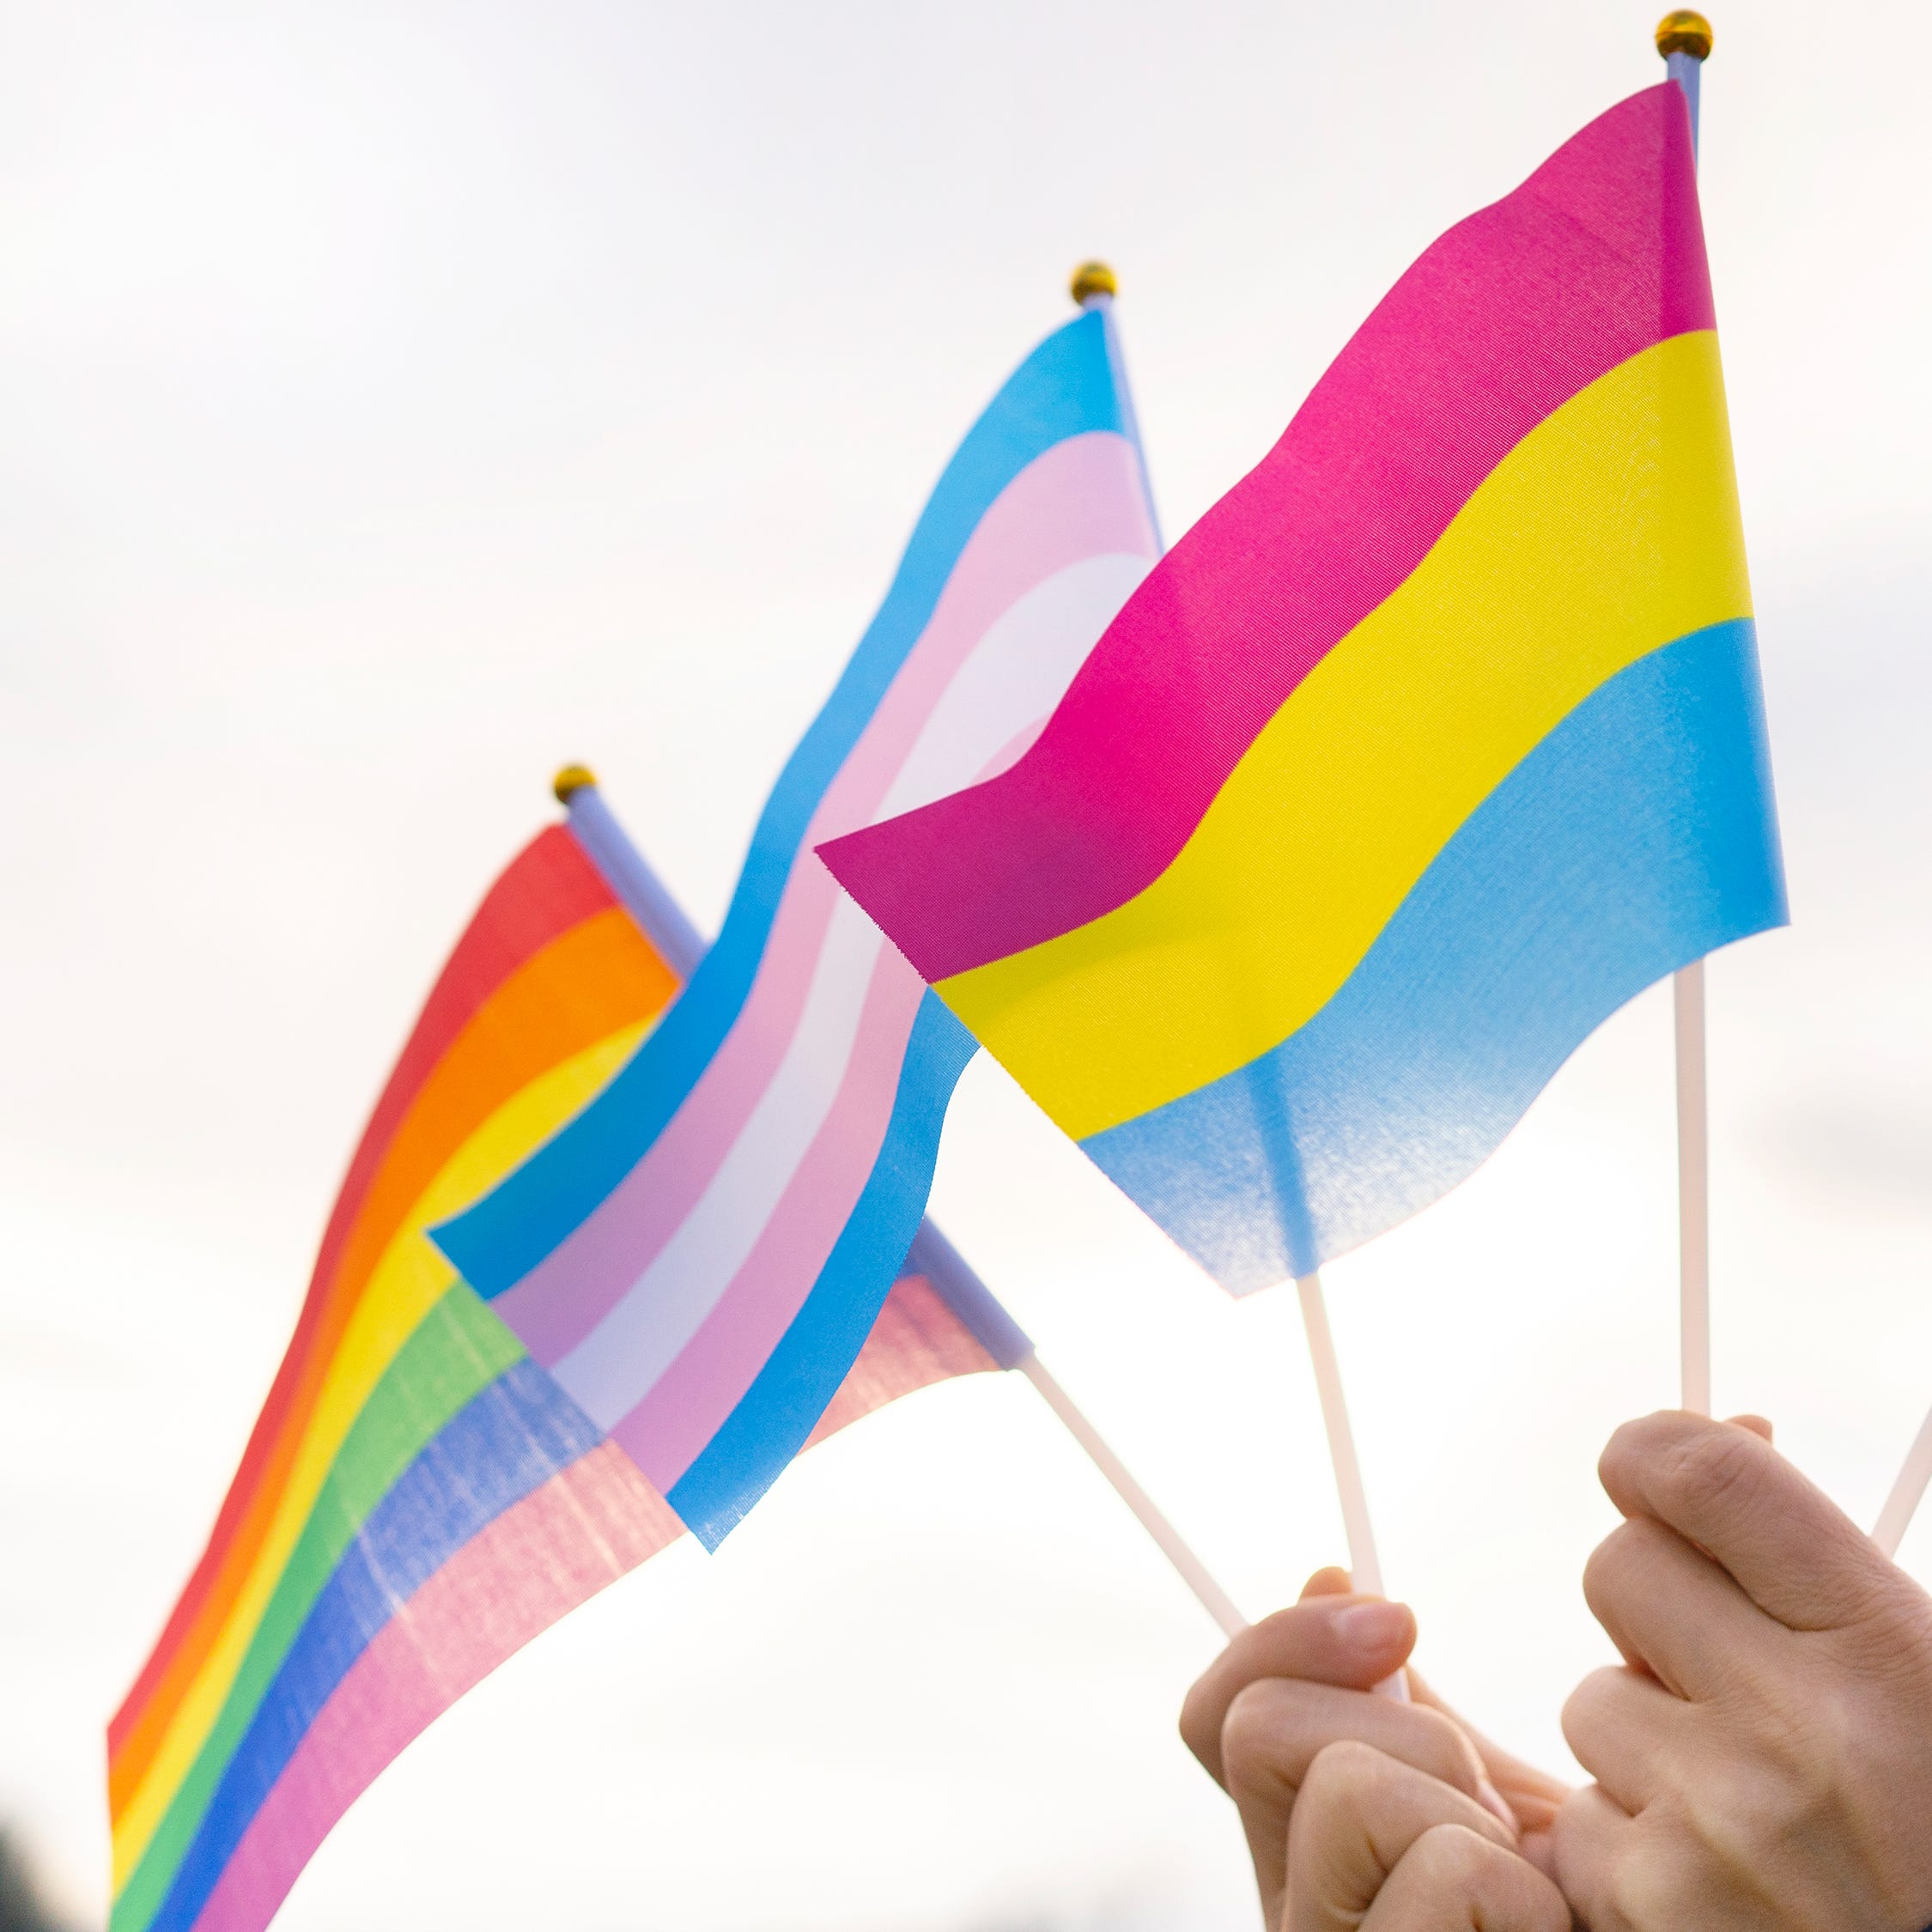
[114,1022,649,1893]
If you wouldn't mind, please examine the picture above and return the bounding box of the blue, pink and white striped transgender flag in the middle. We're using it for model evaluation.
[433,301,1159,1547]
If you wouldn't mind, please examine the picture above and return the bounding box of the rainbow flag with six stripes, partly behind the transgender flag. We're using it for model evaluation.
[108,825,999,1932]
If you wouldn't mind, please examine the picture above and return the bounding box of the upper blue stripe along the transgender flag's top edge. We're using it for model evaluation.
[431,313,1122,1298]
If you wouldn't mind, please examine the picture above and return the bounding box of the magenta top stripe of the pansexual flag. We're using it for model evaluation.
[825,82,1714,981]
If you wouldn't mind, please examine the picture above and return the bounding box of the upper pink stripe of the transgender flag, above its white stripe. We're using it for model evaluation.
[506,431,1157,1366]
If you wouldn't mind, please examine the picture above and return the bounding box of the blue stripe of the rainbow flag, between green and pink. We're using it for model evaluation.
[153,1360,605,1932]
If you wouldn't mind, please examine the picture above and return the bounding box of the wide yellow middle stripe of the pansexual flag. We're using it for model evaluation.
[939,332,1751,1138]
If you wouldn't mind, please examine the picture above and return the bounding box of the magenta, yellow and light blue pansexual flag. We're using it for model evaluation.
[823,83,1785,1292]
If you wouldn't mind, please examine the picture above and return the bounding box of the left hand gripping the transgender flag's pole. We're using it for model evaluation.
[1181,1571,1569,1932]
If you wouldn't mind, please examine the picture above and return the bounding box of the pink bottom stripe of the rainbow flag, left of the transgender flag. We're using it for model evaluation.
[195,1443,684,1932]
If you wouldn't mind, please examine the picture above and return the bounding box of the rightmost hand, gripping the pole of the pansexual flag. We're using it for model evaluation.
[1555,1413,1932,1932]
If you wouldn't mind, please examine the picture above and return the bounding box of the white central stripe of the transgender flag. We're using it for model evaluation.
[553,556,1151,1428]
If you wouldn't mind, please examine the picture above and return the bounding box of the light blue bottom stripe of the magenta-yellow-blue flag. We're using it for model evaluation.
[1082,623,1787,1295]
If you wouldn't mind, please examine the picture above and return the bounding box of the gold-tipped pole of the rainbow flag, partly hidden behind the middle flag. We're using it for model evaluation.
[553,765,1249,1637]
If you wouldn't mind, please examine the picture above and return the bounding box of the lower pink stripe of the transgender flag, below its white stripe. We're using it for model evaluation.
[611,947,926,1490]
